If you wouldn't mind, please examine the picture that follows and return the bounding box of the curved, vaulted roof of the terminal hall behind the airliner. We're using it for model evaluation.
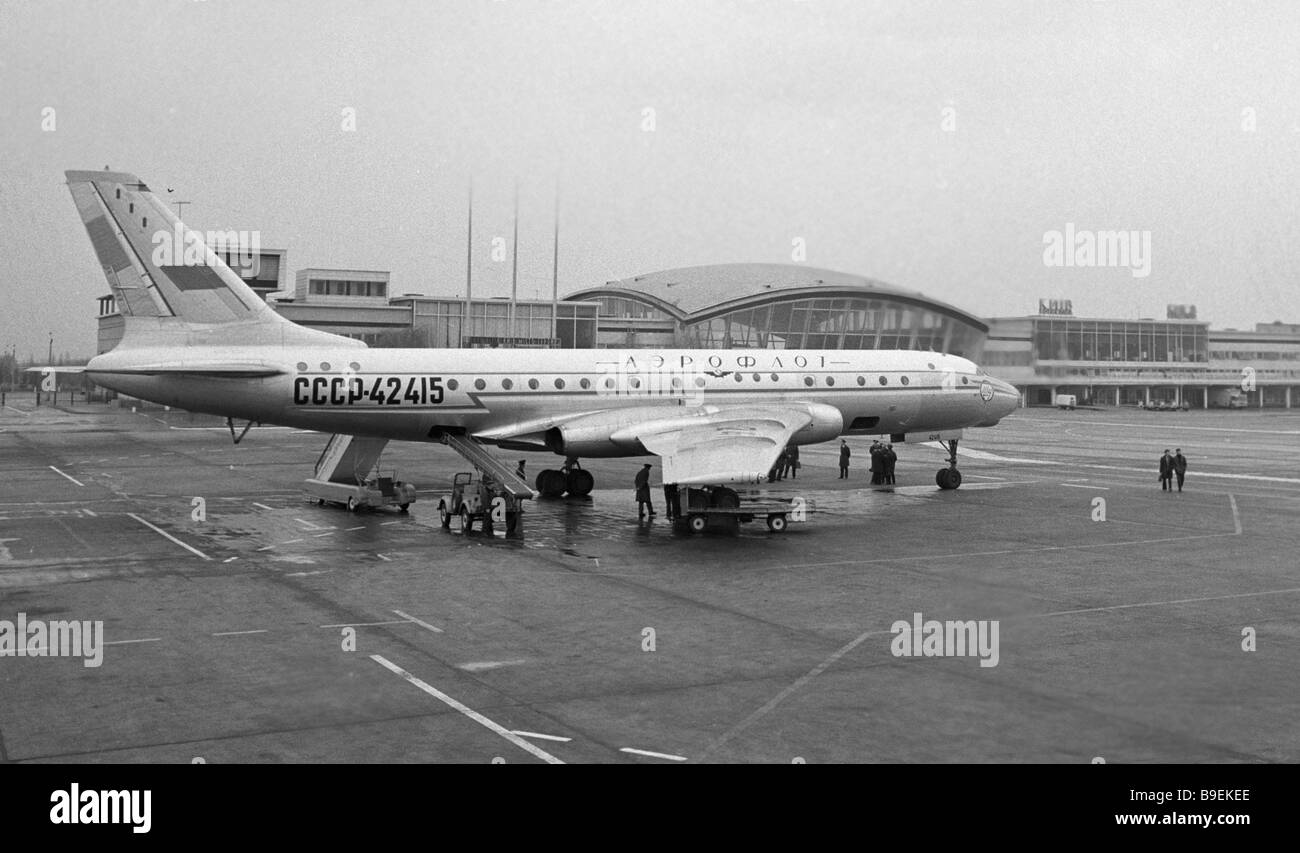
[566,264,988,332]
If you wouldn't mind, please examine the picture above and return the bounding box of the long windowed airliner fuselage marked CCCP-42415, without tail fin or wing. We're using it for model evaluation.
[86,341,1018,456]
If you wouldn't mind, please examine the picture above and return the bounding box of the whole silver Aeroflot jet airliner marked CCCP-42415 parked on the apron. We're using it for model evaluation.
[66,172,1019,509]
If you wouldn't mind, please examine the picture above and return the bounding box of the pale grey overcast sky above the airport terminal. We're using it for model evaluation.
[0,0,1300,358]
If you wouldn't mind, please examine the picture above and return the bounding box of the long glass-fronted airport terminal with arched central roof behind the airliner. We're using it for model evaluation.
[99,258,1300,408]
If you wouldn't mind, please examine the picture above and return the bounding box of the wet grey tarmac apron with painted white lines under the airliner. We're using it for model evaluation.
[0,398,1300,763]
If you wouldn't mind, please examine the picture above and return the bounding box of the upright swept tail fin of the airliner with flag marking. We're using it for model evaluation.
[64,172,287,331]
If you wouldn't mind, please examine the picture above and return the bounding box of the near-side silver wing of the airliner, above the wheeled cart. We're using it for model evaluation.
[631,406,813,485]
